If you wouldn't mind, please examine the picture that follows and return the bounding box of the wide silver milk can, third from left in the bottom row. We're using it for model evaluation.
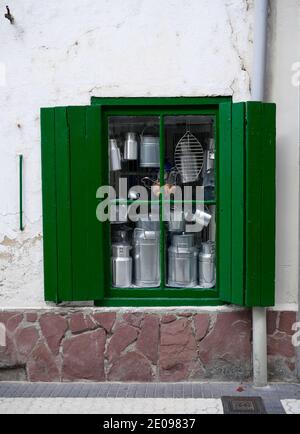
[168,234,198,288]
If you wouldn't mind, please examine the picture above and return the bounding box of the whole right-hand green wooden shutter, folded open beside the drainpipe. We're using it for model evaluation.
[222,102,276,307]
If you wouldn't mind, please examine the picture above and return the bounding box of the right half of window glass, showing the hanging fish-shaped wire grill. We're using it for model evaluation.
[163,115,216,288]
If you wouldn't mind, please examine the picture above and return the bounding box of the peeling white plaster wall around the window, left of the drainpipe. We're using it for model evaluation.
[0,0,298,308]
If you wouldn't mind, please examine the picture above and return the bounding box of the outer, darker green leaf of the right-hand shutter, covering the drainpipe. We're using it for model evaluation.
[245,102,276,306]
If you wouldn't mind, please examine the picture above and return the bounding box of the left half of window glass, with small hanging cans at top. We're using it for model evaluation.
[108,116,160,288]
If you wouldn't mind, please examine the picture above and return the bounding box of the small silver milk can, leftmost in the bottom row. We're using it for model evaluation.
[111,243,132,288]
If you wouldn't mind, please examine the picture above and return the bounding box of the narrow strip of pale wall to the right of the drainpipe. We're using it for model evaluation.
[266,0,300,305]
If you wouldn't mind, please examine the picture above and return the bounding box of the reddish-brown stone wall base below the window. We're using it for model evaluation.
[0,308,296,382]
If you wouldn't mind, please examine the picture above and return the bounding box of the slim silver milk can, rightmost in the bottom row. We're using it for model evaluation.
[199,241,216,288]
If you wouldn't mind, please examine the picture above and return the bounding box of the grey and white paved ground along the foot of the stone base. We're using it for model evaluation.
[0,382,300,414]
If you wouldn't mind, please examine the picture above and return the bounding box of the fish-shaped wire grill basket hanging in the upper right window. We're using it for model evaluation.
[174,131,204,184]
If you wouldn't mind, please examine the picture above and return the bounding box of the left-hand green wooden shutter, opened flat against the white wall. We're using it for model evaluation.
[41,106,107,303]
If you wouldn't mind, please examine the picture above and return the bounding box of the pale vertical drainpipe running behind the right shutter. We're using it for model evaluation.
[252,0,268,387]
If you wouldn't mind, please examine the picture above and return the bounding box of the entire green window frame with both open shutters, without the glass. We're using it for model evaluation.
[41,97,275,306]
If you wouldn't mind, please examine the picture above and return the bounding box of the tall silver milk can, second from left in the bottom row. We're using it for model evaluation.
[133,222,160,288]
